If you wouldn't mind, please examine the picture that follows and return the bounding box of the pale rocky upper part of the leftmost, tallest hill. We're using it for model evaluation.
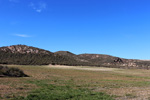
[0,45,51,54]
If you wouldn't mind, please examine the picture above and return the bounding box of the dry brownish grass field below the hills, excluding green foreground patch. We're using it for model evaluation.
[0,65,150,100]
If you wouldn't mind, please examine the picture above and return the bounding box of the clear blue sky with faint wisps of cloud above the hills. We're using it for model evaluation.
[0,0,150,59]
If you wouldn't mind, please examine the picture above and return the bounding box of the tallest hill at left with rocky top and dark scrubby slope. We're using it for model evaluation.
[0,45,79,65]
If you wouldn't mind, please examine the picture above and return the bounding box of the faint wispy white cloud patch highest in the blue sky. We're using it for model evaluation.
[29,2,47,13]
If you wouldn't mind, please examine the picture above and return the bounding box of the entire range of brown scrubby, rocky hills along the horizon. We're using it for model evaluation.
[0,45,150,69]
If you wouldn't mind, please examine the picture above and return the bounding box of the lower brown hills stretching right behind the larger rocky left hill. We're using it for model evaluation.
[55,51,150,69]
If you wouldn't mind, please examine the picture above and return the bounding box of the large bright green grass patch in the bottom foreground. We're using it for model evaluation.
[13,81,114,100]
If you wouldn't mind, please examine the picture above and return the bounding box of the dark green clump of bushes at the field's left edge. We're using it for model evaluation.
[0,66,28,77]
